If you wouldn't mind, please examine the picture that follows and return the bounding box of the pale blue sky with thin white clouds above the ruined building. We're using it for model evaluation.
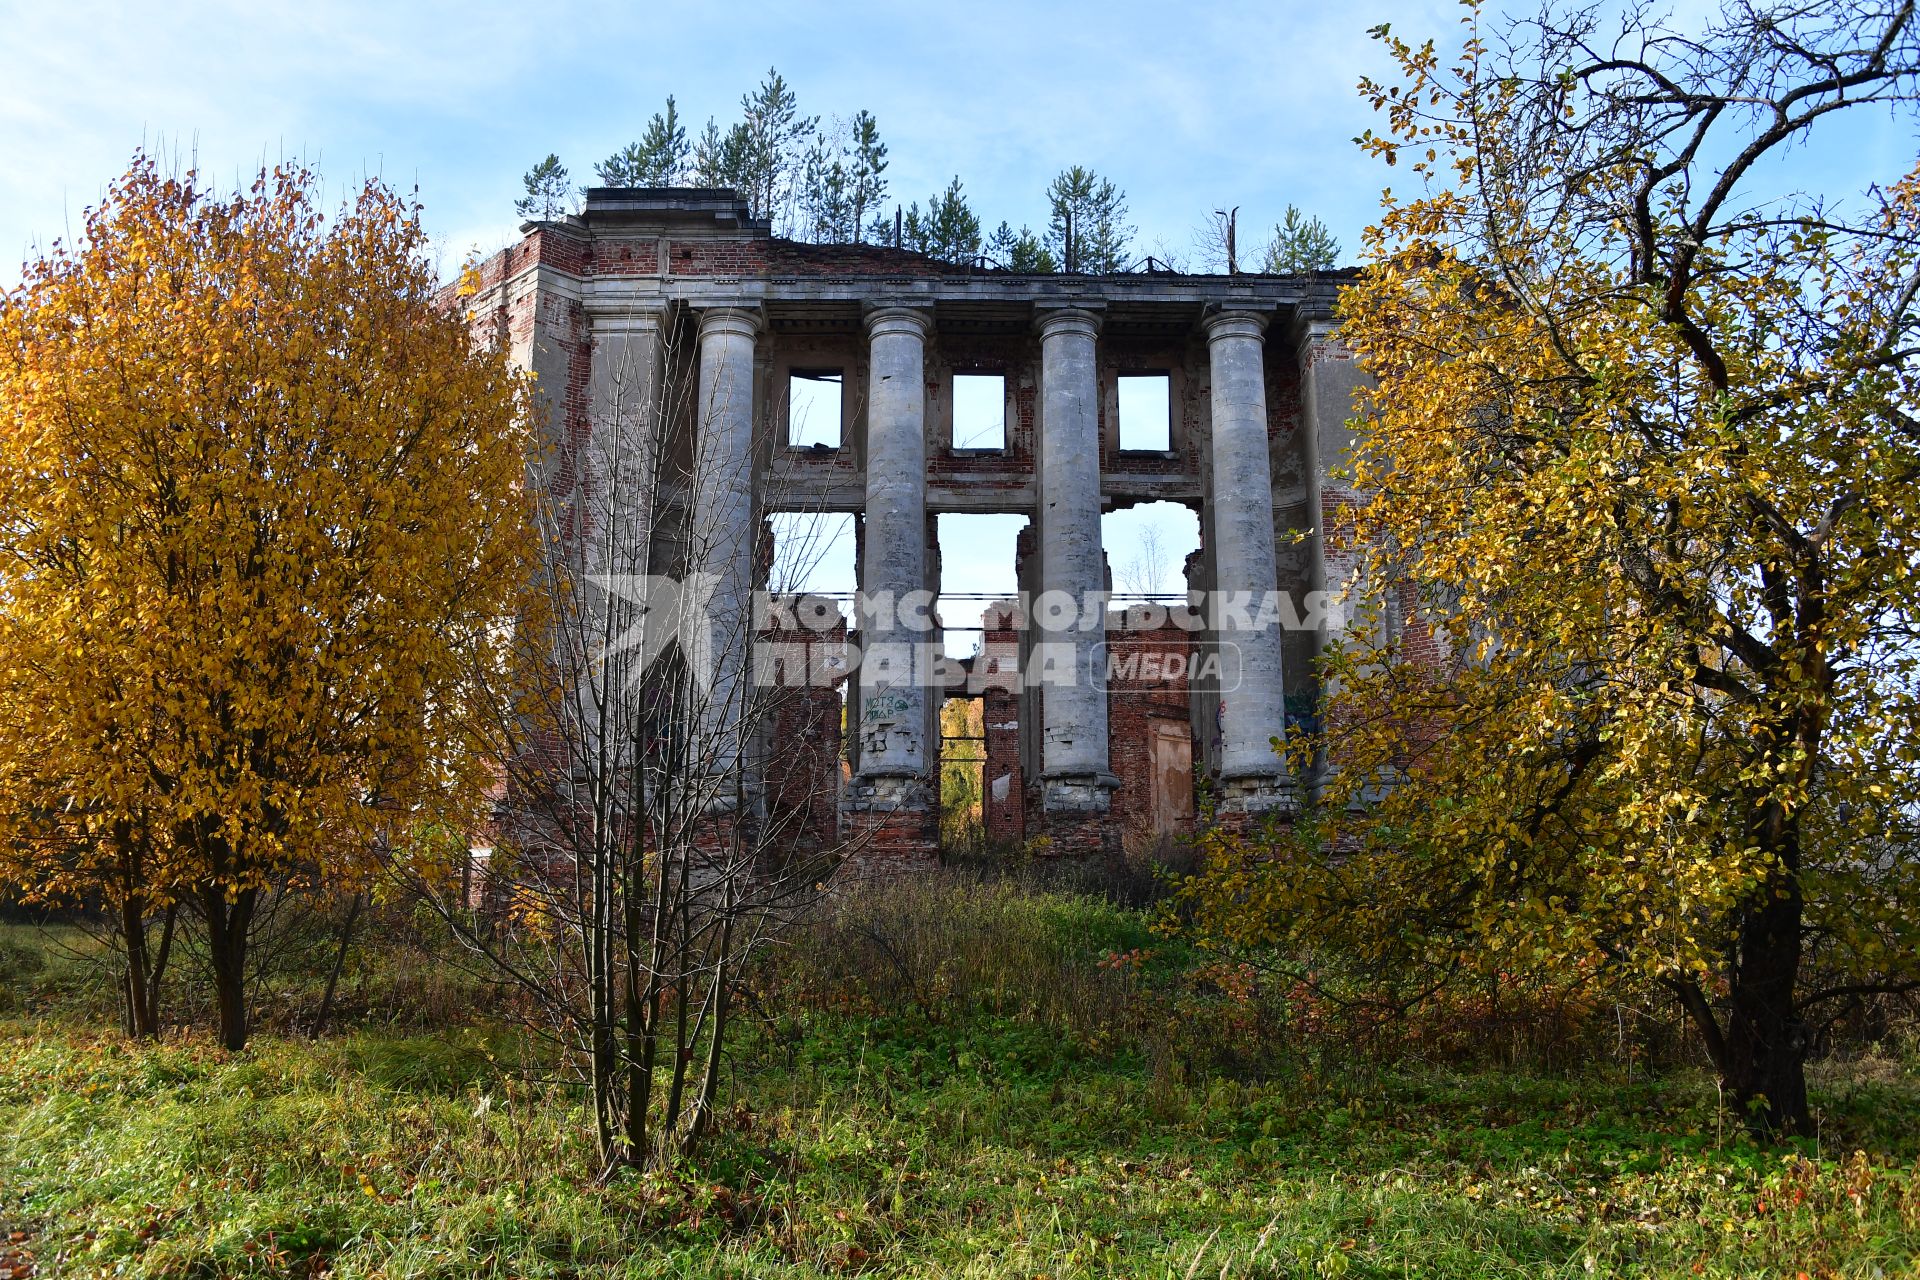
[0,0,1912,652]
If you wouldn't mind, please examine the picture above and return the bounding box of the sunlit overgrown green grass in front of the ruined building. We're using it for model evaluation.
[0,887,1920,1280]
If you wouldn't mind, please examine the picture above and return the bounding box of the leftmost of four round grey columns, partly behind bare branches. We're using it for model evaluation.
[687,307,760,773]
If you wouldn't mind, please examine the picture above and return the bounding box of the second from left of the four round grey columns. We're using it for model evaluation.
[860,307,933,798]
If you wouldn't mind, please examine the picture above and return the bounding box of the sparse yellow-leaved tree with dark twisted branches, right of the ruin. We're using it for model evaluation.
[1188,0,1920,1132]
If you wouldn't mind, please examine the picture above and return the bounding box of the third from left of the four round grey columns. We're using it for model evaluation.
[1029,309,1119,810]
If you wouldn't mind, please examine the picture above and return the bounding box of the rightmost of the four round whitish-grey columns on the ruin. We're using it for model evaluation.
[1206,311,1290,808]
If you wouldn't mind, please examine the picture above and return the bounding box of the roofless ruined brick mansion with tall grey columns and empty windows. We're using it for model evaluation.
[467,188,1390,864]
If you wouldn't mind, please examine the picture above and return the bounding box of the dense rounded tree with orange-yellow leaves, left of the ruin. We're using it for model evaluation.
[0,155,532,1050]
